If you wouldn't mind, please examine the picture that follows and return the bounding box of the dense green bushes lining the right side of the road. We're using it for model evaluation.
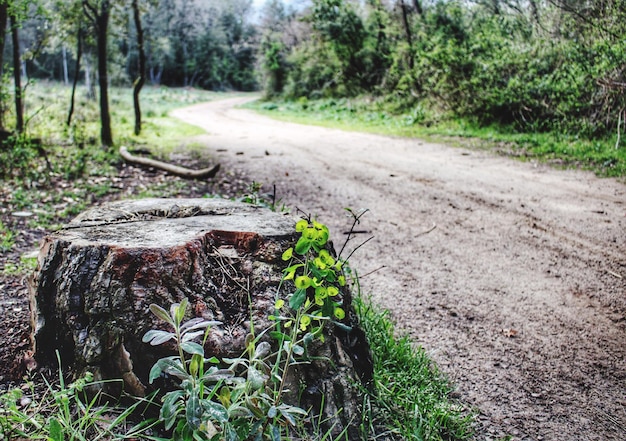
[268,0,626,139]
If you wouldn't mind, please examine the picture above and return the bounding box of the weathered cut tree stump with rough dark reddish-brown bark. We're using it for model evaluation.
[31,199,371,432]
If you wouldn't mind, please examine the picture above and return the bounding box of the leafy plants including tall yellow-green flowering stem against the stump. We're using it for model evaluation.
[143,220,354,440]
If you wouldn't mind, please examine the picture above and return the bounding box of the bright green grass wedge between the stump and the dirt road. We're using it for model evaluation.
[355,297,474,441]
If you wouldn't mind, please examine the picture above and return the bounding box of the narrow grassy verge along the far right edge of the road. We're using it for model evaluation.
[247,98,626,178]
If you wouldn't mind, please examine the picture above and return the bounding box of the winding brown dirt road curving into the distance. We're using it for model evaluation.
[175,98,626,440]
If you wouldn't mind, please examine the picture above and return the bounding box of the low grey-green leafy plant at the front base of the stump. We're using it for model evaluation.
[144,299,306,440]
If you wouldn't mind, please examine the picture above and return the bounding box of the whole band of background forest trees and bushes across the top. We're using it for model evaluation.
[0,0,626,162]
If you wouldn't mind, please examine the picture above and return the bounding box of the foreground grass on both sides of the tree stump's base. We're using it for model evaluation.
[0,290,474,441]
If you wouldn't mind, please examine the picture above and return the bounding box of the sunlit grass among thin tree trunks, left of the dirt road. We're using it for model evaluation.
[0,82,228,234]
